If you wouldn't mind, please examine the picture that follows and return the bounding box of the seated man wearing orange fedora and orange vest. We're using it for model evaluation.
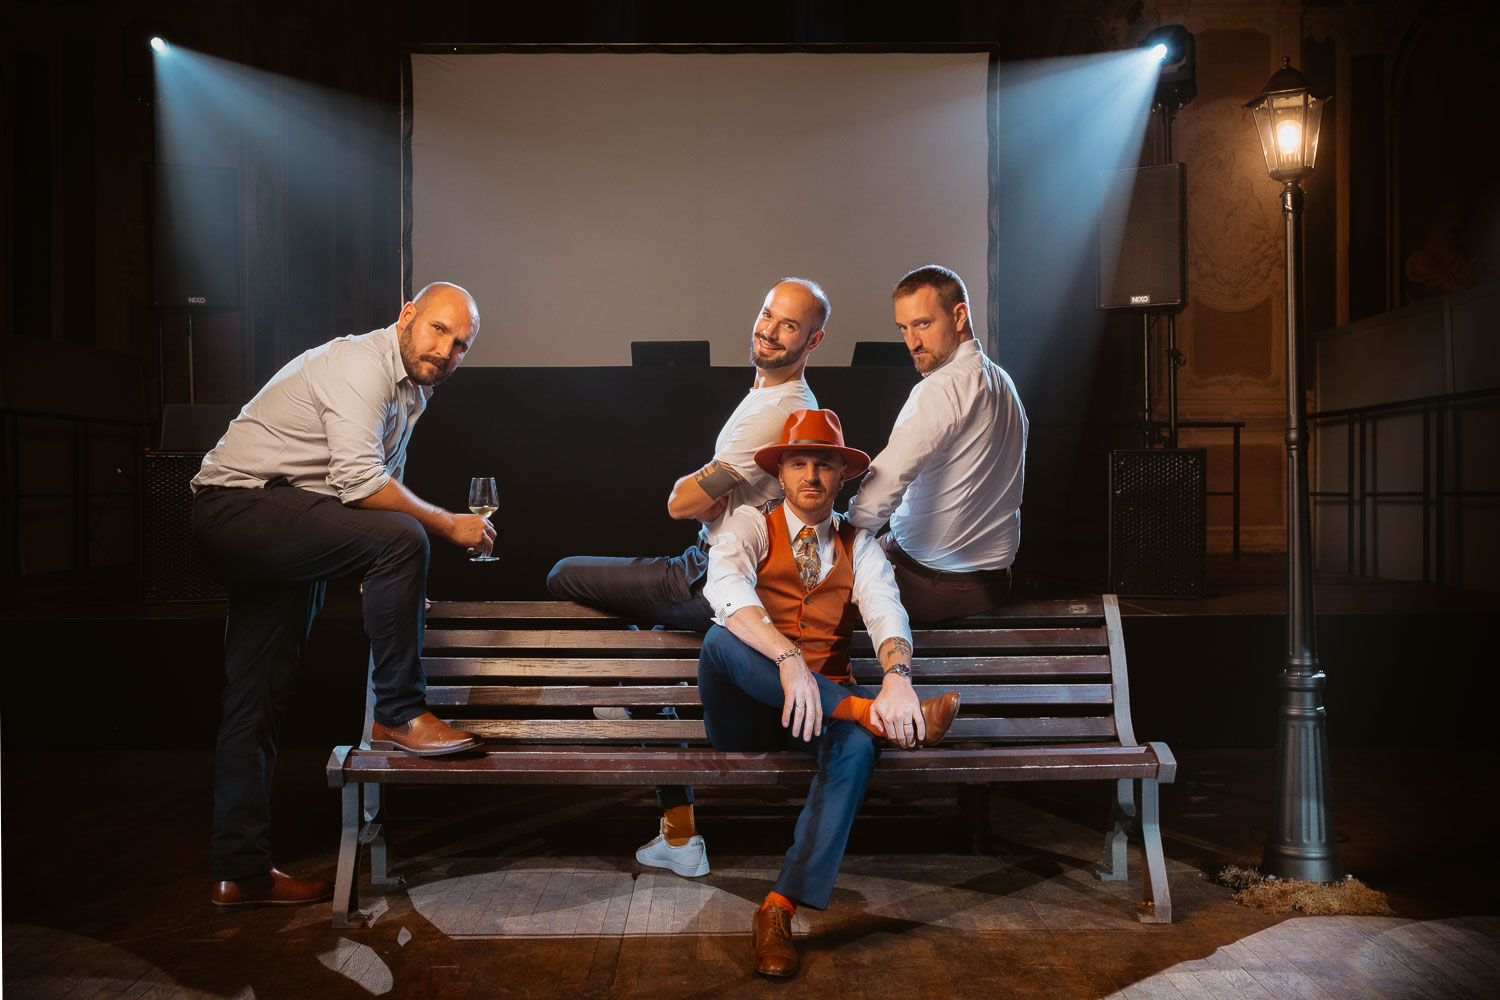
[698,409,959,976]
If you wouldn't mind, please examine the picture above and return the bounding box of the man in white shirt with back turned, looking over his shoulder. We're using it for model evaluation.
[849,265,1028,625]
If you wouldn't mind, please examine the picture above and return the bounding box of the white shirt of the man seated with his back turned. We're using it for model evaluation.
[849,339,1028,573]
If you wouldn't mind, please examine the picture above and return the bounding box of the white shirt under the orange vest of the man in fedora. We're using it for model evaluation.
[704,504,912,649]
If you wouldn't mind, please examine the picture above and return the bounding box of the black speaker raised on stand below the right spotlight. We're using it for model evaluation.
[1095,163,1188,309]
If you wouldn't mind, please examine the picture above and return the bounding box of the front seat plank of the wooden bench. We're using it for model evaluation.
[337,745,1158,786]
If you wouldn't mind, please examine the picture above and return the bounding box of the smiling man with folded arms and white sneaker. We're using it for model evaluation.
[548,277,830,879]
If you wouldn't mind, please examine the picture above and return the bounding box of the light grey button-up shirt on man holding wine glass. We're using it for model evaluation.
[192,325,432,504]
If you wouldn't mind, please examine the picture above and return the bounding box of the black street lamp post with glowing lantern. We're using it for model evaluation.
[1245,58,1341,882]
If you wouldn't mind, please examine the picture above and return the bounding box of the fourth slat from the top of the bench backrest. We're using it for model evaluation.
[428,684,1113,708]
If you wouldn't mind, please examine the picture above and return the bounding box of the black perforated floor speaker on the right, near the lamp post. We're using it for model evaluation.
[1110,448,1208,597]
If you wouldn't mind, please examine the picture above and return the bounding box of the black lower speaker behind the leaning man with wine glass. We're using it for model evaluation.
[141,451,225,603]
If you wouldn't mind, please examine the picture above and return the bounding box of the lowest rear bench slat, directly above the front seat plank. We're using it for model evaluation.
[447,715,1115,744]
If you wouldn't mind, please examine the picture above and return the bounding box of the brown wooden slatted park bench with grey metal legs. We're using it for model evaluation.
[327,595,1176,927]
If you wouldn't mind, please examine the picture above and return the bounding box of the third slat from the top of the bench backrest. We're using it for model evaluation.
[422,654,1110,684]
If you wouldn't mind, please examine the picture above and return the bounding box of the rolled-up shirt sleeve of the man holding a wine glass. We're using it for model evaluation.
[314,355,395,504]
